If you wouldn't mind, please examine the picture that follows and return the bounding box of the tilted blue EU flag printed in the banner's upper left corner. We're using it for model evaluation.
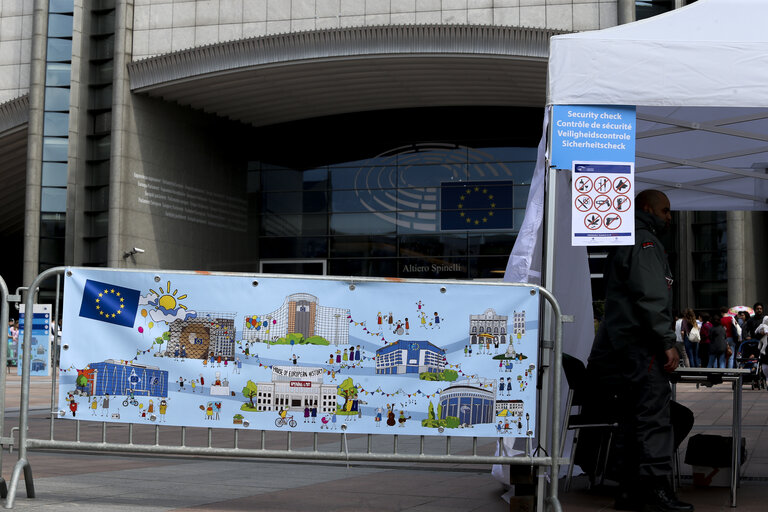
[80,279,140,327]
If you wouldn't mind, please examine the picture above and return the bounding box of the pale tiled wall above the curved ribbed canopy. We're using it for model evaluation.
[133,0,617,60]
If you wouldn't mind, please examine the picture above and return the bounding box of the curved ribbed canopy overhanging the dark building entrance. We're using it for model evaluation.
[128,25,561,126]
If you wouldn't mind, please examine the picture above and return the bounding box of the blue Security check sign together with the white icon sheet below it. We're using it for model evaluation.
[551,105,636,245]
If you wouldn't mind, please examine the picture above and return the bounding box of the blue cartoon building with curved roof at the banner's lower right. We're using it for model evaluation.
[440,381,496,425]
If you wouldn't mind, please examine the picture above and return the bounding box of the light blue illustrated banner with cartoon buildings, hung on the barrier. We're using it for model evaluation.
[59,268,540,437]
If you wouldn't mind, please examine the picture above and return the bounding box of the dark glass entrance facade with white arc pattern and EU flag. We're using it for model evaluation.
[248,143,536,279]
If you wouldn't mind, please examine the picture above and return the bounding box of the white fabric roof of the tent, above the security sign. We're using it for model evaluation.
[547,0,768,107]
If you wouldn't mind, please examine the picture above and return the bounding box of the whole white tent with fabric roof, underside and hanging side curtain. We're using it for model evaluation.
[498,0,768,496]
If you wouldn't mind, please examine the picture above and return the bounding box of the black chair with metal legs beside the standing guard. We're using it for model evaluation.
[560,354,618,491]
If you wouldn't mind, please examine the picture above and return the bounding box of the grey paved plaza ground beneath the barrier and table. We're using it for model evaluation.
[2,375,768,512]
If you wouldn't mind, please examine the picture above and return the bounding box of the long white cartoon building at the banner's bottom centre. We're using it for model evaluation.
[255,366,337,413]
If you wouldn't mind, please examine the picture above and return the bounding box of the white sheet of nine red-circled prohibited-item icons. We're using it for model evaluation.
[571,162,635,245]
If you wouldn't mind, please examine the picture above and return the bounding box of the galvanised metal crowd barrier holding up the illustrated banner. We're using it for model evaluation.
[0,267,567,512]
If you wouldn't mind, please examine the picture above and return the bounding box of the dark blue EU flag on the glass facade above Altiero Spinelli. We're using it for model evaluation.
[440,181,515,230]
